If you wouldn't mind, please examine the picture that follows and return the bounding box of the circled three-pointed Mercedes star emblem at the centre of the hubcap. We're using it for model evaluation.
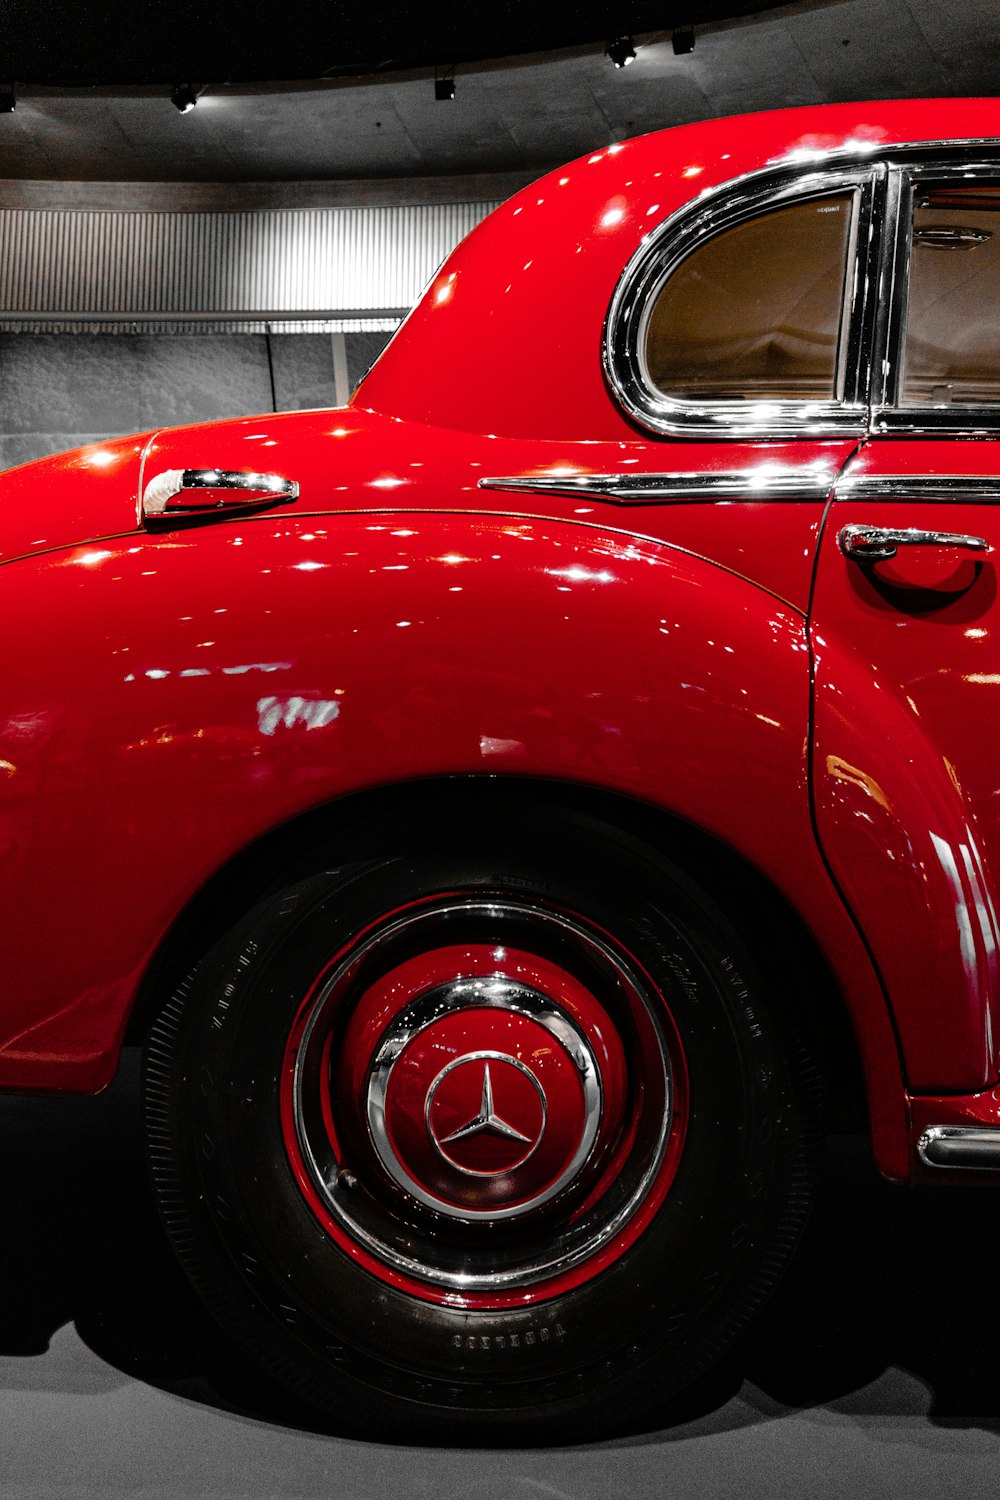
[424,1052,547,1178]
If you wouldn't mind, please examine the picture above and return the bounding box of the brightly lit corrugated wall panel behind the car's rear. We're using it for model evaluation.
[0,203,496,321]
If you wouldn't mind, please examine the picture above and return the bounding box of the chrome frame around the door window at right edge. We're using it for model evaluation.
[871,152,1000,438]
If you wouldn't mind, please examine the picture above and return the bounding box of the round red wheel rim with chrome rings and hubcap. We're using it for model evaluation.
[282,893,687,1308]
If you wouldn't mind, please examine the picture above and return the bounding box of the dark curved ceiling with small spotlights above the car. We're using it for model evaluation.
[0,0,1000,193]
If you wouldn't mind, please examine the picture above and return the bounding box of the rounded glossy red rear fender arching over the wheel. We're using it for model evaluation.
[0,512,906,1170]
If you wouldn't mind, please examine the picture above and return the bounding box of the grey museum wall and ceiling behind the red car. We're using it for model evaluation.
[0,0,996,468]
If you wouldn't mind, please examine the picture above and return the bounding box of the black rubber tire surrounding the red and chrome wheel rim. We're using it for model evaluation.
[144,800,820,1440]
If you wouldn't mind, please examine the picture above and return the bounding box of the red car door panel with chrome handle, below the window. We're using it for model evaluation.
[813,440,1000,1092]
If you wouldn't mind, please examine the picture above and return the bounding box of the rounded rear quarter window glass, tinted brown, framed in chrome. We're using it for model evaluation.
[643,191,858,401]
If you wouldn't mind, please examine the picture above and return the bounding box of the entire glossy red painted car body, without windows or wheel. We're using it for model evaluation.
[19,101,1000,1176]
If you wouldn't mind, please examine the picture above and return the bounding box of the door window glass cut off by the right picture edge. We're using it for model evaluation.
[900,185,1000,407]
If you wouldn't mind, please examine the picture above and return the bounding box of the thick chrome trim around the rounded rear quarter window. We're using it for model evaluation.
[603,159,886,438]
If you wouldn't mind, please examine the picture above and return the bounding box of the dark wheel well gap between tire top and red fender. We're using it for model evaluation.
[126,777,867,1130]
